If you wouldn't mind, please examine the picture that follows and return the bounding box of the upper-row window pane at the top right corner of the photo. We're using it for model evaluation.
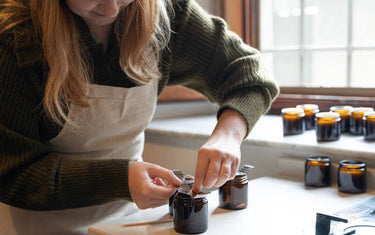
[353,0,375,46]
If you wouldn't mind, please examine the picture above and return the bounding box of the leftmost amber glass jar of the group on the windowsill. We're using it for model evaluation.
[281,108,305,135]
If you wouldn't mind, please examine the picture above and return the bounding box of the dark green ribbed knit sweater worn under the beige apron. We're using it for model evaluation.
[0,0,278,210]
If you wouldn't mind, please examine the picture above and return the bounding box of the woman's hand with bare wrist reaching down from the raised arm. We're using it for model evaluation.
[192,109,247,193]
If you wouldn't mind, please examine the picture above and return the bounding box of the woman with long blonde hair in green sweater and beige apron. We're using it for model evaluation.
[0,0,278,234]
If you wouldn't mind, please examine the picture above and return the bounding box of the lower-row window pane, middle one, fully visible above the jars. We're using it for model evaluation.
[303,51,347,87]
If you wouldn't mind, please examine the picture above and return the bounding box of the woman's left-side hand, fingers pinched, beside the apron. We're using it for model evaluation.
[128,162,181,209]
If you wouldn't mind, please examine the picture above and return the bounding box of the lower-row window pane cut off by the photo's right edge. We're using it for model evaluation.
[352,51,375,87]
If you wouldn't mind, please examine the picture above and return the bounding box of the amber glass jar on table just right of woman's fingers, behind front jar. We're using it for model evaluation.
[219,172,248,210]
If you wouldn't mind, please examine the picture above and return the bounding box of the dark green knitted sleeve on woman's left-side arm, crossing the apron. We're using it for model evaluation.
[0,35,130,210]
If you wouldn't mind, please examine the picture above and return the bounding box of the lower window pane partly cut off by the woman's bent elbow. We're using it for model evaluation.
[263,52,301,86]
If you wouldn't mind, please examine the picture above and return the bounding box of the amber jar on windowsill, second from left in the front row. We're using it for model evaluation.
[315,112,341,141]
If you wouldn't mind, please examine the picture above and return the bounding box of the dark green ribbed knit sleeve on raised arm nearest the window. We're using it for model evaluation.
[168,0,279,136]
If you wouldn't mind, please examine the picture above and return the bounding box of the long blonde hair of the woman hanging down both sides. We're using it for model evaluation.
[0,0,171,125]
